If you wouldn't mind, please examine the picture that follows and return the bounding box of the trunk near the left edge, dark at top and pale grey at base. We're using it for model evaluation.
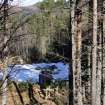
[0,0,8,105]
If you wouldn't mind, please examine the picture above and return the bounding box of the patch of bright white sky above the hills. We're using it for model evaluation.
[12,0,42,6]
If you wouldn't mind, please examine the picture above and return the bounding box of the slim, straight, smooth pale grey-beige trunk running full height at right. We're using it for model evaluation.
[92,0,97,105]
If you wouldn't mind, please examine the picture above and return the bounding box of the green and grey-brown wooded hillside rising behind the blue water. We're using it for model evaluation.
[6,1,70,63]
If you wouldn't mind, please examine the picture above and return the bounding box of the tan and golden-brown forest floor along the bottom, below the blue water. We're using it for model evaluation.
[0,85,69,105]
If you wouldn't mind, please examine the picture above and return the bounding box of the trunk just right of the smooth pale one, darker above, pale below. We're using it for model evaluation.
[96,0,103,105]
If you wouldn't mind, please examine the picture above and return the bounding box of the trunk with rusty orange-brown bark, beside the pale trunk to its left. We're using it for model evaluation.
[75,7,83,105]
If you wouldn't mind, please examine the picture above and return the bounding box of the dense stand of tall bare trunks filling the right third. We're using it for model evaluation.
[70,0,105,105]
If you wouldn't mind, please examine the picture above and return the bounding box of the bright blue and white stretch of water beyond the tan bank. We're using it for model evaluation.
[0,62,70,83]
